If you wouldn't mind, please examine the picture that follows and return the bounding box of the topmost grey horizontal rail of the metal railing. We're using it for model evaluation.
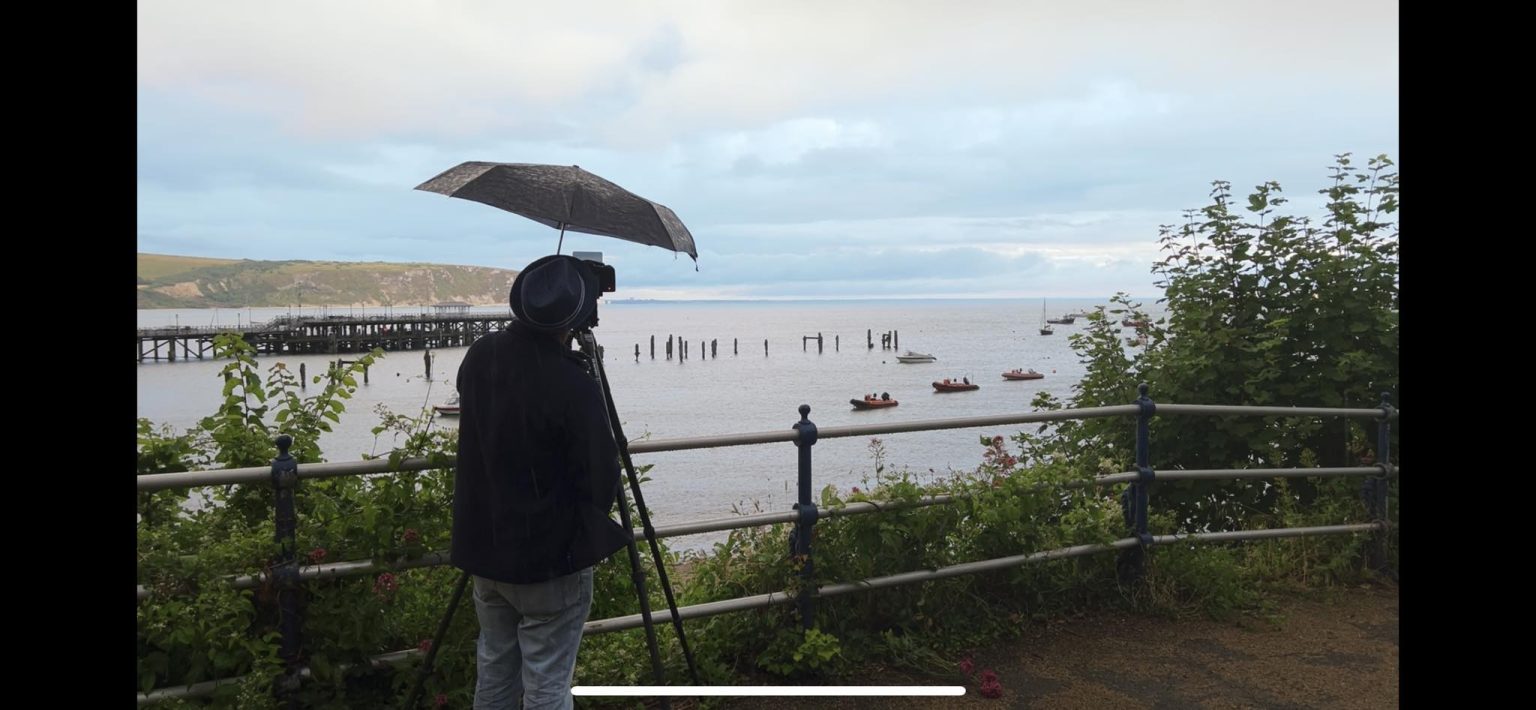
[138,404,1398,492]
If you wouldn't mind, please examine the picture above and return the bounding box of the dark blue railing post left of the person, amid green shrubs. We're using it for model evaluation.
[270,433,301,704]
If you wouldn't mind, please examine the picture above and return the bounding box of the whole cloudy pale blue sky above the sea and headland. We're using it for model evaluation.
[137,0,1399,300]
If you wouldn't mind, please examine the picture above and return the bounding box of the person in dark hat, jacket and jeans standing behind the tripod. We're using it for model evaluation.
[452,255,630,710]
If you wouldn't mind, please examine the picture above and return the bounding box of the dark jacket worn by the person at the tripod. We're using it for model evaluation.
[452,321,630,584]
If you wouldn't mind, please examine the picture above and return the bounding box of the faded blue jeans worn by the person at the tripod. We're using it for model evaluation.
[475,567,591,710]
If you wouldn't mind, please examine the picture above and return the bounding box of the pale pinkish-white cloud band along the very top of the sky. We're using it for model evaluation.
[138,0,1398,148]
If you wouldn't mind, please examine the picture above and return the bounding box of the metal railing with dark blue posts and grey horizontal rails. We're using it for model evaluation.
[137,384,1399,704]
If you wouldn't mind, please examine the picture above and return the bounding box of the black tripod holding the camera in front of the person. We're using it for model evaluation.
[404,324,699,708]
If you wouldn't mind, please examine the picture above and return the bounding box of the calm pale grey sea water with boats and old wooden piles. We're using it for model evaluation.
[138,300,1158,547]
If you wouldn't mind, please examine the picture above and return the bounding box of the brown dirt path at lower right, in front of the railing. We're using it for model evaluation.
[712,586,1399,710]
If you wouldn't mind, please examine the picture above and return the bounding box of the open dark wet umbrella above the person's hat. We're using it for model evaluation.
[416,161,699,263]
